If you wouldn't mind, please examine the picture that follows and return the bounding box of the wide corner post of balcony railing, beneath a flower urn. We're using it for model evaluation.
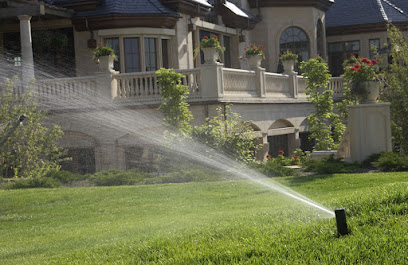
[200,63,224,99]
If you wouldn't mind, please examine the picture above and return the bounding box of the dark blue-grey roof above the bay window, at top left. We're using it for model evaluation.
[65,0,179,17]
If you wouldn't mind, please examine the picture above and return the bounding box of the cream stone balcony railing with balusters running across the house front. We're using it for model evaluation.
[29,64,344,105]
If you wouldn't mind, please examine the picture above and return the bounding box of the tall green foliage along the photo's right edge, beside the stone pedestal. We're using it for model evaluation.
[380,25,408,154]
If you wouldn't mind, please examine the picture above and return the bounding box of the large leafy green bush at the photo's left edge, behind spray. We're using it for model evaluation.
[0,80,64,178]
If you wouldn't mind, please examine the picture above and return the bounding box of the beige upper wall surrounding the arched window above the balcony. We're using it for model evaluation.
[249,7,325,72]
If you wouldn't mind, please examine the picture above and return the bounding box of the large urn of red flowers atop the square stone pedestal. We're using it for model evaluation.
[344,57,379,103]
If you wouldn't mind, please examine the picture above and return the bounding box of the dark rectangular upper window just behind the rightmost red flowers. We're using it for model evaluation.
[329,41,360,76]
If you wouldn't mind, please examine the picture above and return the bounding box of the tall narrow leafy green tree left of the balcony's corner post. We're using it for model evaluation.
[156,68,193,135]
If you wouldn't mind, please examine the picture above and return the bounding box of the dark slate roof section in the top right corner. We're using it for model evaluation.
[326,0,408,28]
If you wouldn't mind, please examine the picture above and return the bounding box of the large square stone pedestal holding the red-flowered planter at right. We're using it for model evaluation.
[347,102,392,162]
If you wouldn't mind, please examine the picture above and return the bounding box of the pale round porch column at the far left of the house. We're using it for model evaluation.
[18,15,34,83]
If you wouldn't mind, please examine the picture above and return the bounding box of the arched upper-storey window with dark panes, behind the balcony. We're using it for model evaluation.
[279,27,310,71]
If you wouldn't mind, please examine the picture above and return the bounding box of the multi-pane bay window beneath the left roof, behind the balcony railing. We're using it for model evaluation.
[104,36,170,73]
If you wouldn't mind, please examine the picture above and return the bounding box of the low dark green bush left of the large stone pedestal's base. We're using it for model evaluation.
[305,155,359,175]
